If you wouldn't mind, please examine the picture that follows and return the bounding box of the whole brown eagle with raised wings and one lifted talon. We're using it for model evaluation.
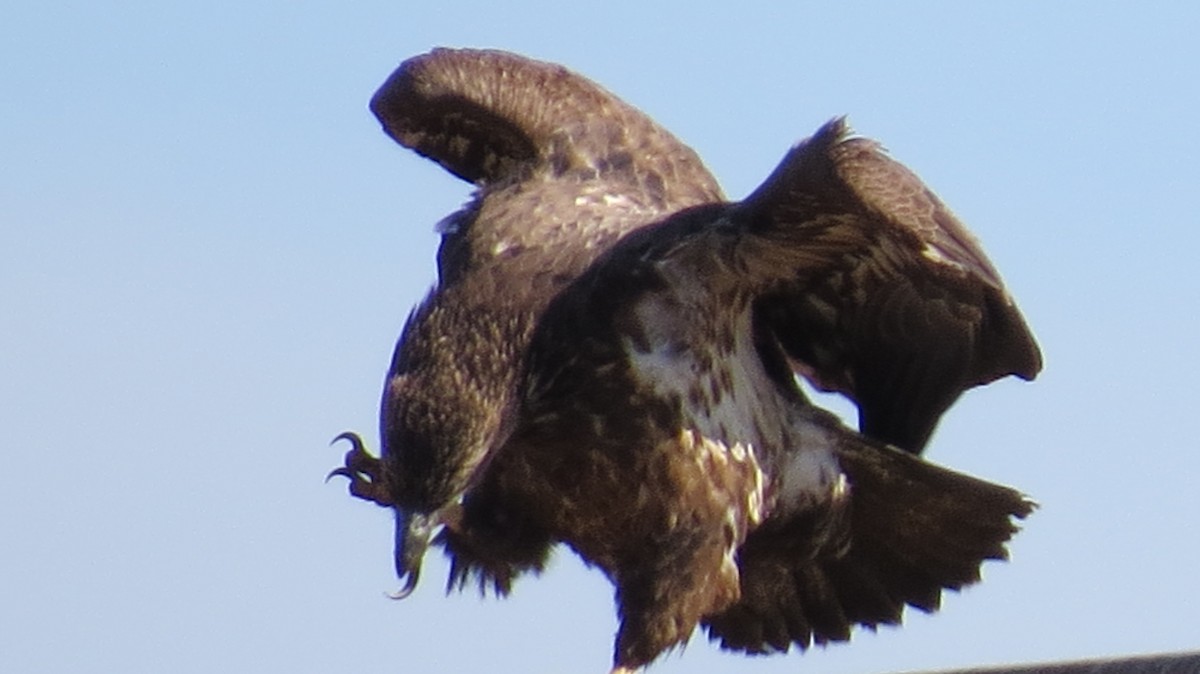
[329,48,1042,674]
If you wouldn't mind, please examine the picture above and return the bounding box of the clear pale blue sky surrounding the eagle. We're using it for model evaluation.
[0,0,1200,674]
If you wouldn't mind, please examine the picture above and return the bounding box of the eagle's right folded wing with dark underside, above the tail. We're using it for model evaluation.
[731,119,1042,452]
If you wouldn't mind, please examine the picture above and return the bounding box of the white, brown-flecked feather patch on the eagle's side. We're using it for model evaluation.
[622,260,846,529]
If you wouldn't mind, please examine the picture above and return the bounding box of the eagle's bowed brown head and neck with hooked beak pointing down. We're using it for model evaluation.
[378,287,528,596]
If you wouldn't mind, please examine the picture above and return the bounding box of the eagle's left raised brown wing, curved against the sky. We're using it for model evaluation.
[371,49,720,203]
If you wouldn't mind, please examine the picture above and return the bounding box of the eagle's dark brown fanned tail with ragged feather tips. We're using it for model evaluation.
[704,440,1034,652]
